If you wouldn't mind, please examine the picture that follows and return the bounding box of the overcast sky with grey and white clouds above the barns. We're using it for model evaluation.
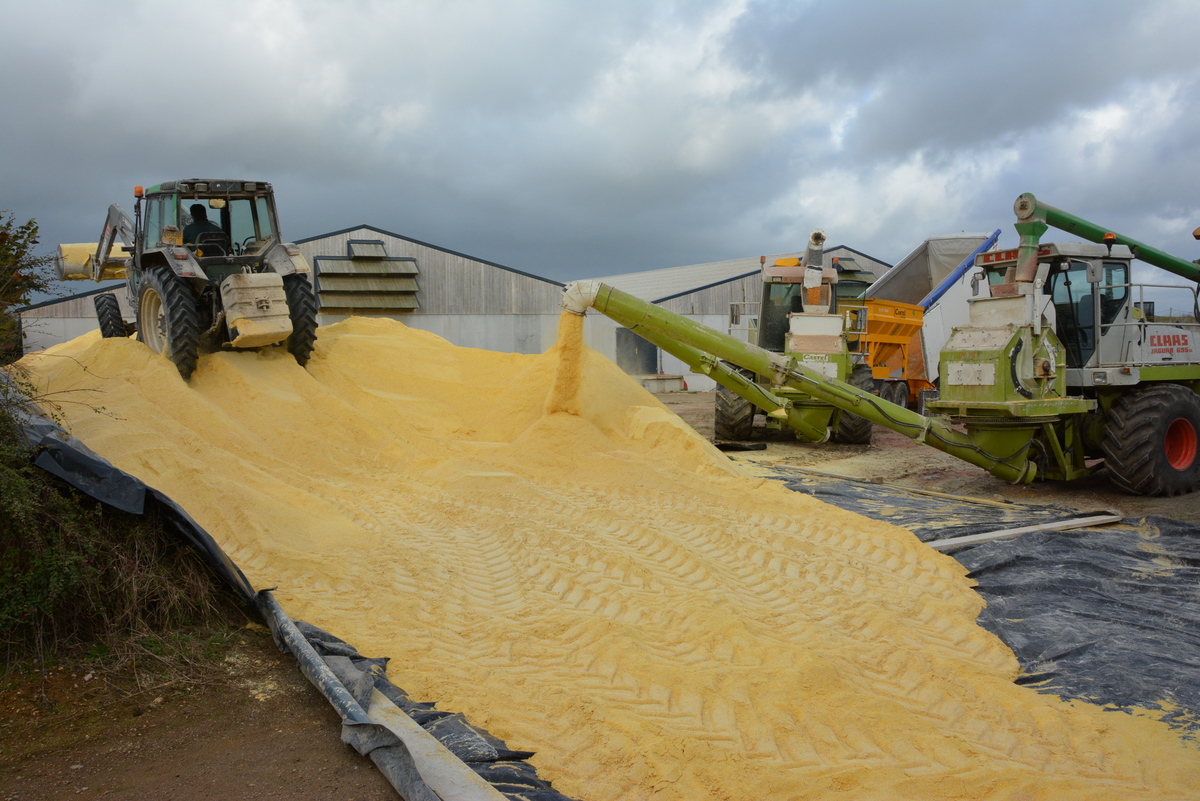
[0,0,1200,292]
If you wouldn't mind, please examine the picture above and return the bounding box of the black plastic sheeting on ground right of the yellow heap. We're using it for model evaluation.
[775,471,1200,739]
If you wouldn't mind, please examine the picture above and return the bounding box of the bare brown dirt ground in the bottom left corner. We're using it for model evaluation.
[0,624,397,801]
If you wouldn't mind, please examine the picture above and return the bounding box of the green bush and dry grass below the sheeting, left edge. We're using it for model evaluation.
[0,392,245,664]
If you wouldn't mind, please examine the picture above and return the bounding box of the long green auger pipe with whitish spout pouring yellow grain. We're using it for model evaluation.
[563,281,1037,483]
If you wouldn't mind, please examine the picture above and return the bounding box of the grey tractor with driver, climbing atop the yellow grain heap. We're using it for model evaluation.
[59,179,317,380]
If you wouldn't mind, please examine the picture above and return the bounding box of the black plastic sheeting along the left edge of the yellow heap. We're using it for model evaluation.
[8,372,572,801]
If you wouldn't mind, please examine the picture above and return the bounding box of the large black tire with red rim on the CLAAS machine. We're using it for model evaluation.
[1103,384,1200,495]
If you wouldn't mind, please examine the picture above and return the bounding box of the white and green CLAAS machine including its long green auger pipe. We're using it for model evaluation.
[563,193,1200,495]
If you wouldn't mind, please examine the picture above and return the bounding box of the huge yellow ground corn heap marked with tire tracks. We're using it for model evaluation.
[25,315,1200,801]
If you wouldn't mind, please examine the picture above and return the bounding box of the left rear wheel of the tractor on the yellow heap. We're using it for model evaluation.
[138,266,200,381]
